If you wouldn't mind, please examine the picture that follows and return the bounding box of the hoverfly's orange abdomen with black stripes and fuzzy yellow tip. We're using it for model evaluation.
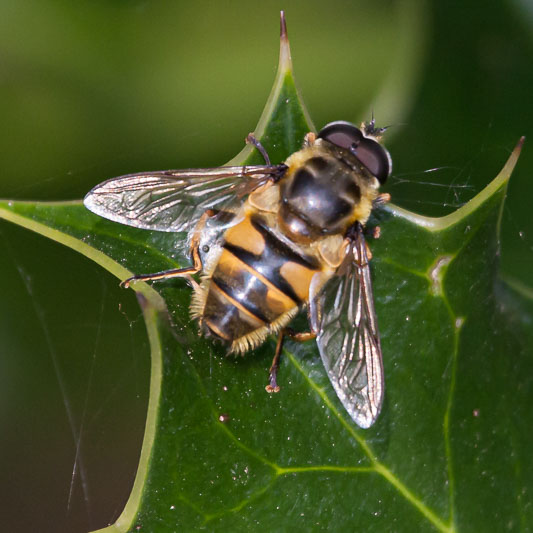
[197,213,320,352]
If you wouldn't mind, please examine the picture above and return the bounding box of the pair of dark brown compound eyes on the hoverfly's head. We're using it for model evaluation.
[318,121,391,185]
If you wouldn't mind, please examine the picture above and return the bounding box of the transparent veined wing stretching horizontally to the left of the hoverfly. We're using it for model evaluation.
[84,165,286,232]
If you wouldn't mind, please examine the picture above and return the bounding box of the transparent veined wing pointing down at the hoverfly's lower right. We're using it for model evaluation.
[317,231,384,428]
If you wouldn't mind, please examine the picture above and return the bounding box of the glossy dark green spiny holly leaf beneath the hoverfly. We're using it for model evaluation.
[0,13,533,532]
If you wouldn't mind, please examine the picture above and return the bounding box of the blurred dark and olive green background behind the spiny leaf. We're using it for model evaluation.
[0,0,533,532]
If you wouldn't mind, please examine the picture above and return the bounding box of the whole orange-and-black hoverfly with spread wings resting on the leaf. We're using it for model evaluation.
[84,120,392,428]
